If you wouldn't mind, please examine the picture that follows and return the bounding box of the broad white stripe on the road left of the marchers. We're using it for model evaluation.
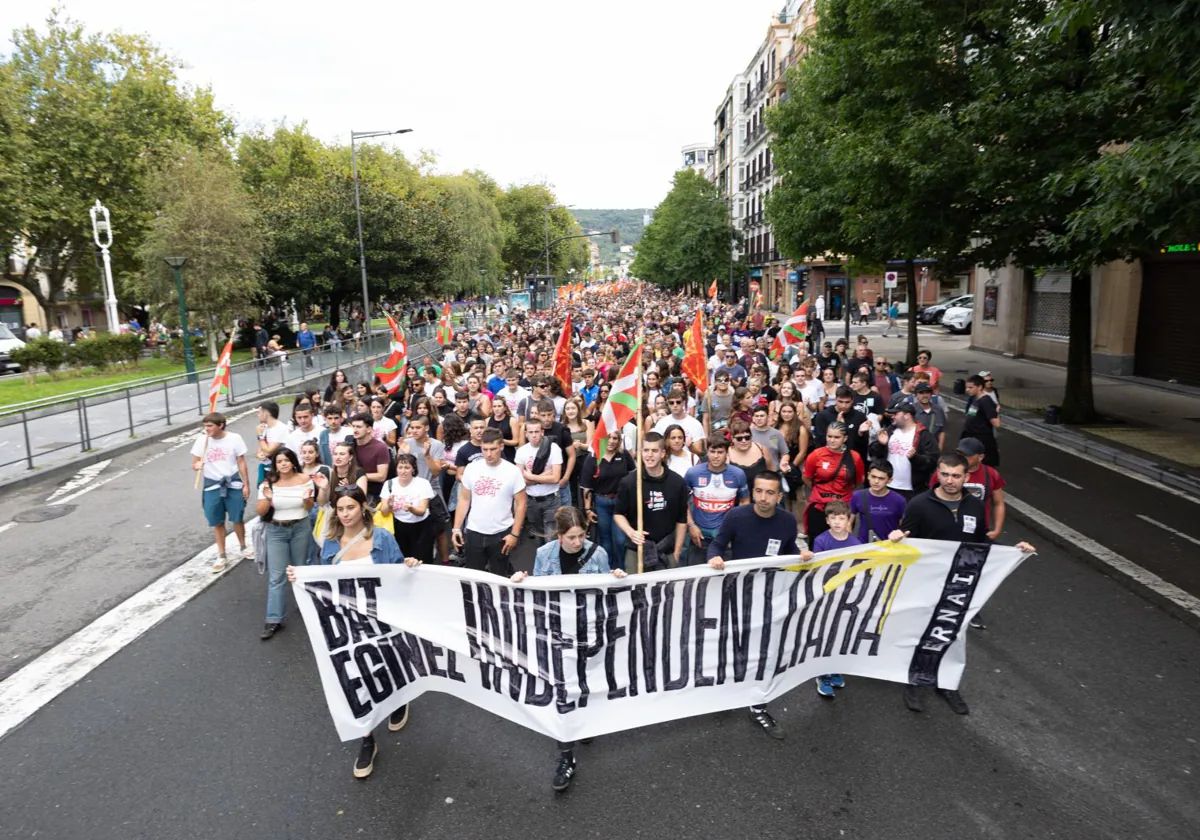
[0,518,258,738]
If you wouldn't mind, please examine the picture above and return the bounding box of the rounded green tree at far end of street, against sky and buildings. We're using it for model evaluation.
[630,169,737,293]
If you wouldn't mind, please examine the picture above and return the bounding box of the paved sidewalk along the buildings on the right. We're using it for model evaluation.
[811,324,1200,491]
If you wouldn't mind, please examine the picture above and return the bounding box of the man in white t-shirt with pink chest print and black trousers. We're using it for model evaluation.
[450,428,526,577]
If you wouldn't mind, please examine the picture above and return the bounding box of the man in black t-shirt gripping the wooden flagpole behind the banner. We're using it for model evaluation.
[613,432,688,571]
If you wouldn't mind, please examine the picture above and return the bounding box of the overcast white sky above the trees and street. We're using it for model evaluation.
[0,0,784,208]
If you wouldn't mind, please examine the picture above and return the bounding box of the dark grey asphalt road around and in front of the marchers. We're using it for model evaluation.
[0,355,1200,840]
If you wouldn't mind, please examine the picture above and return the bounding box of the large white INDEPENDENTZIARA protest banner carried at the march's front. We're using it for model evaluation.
[294,540,1024,740]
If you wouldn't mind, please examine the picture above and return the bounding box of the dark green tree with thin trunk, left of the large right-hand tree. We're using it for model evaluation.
[767,0,974,362]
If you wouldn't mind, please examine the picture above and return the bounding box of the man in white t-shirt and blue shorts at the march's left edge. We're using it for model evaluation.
[192,413,254,572]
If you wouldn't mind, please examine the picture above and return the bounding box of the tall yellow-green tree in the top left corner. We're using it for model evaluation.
[0,11,232,308]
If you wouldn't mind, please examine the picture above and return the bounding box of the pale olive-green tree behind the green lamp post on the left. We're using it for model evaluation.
[131,150,264,361]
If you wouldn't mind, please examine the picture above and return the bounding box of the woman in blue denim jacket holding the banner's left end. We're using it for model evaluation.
[287,484,421,779]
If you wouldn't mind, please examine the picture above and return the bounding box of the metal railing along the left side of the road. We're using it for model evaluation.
[0,324,437,472]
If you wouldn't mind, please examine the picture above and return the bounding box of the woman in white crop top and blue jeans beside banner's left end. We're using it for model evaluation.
[256,446,317,642]
